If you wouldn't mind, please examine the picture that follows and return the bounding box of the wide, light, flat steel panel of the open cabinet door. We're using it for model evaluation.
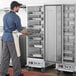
[45,6,56,61]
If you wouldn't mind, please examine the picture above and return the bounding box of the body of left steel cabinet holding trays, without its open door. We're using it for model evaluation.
[26,6,45,71]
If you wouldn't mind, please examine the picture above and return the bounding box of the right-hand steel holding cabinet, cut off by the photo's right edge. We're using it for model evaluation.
[56,4,76,73]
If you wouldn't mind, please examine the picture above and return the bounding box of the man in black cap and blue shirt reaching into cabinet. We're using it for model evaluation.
[0,1,27,76]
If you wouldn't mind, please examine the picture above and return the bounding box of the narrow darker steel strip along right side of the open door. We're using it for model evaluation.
[56,6,62,62]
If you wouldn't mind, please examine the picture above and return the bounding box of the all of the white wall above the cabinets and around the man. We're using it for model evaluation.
[0,0,76,26]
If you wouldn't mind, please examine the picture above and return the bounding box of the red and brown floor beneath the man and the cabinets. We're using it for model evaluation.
[9,67,73,76]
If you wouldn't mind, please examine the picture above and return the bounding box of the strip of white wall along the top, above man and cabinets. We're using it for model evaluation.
[0,0,76,8]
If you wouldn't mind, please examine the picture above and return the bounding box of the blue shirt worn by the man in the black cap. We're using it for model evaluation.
[2,11,22,41]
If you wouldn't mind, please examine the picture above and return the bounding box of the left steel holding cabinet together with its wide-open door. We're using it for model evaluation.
[26,5,62,68]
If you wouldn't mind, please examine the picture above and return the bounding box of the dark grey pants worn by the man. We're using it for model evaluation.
[0,42,21,76]
